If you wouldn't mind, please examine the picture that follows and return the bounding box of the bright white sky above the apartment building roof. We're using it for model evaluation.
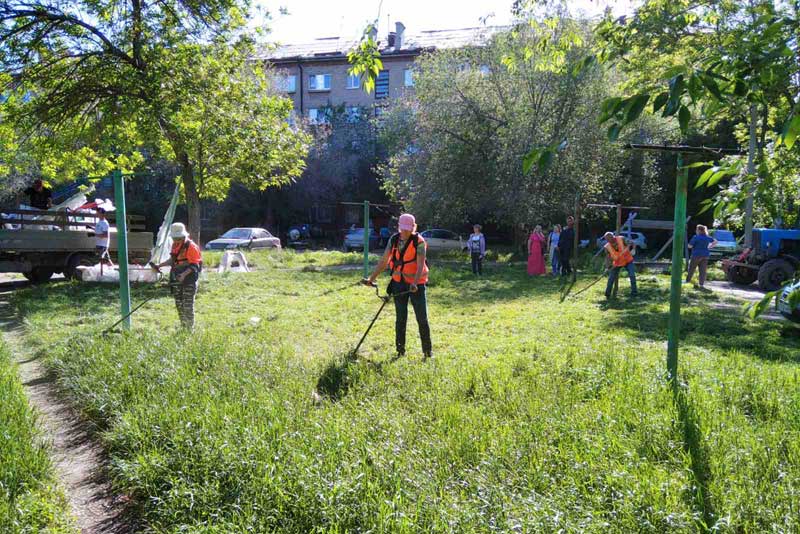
[254,0,632,44]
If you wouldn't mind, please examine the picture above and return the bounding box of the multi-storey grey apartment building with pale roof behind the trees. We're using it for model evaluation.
[259,22,507,122]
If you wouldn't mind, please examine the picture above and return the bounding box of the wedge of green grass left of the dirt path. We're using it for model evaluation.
[0,344,74,533]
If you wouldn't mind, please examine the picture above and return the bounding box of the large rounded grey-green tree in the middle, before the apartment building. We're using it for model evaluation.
[380,18,655,237]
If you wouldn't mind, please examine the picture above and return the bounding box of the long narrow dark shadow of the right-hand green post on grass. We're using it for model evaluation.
[672,381,716,532]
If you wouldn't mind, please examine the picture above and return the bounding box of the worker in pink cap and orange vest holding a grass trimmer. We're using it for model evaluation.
[364,213,433,359]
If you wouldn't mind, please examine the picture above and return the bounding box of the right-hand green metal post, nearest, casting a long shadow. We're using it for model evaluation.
[667,152,689,382]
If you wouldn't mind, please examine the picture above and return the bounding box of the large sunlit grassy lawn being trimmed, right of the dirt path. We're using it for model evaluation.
[10,252,800,532]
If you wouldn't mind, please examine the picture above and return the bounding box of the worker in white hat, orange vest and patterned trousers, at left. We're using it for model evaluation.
[155,223,203,331]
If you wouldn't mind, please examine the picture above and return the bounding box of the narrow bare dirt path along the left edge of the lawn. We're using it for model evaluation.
[0,278,135,534]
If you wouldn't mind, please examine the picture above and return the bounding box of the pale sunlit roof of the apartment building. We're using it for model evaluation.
[257,26,509,61]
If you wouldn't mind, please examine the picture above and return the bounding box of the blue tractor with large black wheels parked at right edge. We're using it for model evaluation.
[722,228,800,291]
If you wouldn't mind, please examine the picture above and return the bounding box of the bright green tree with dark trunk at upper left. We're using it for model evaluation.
[0,0,307,238]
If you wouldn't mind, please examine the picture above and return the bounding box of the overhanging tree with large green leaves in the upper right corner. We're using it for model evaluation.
[596,0,800,244]
